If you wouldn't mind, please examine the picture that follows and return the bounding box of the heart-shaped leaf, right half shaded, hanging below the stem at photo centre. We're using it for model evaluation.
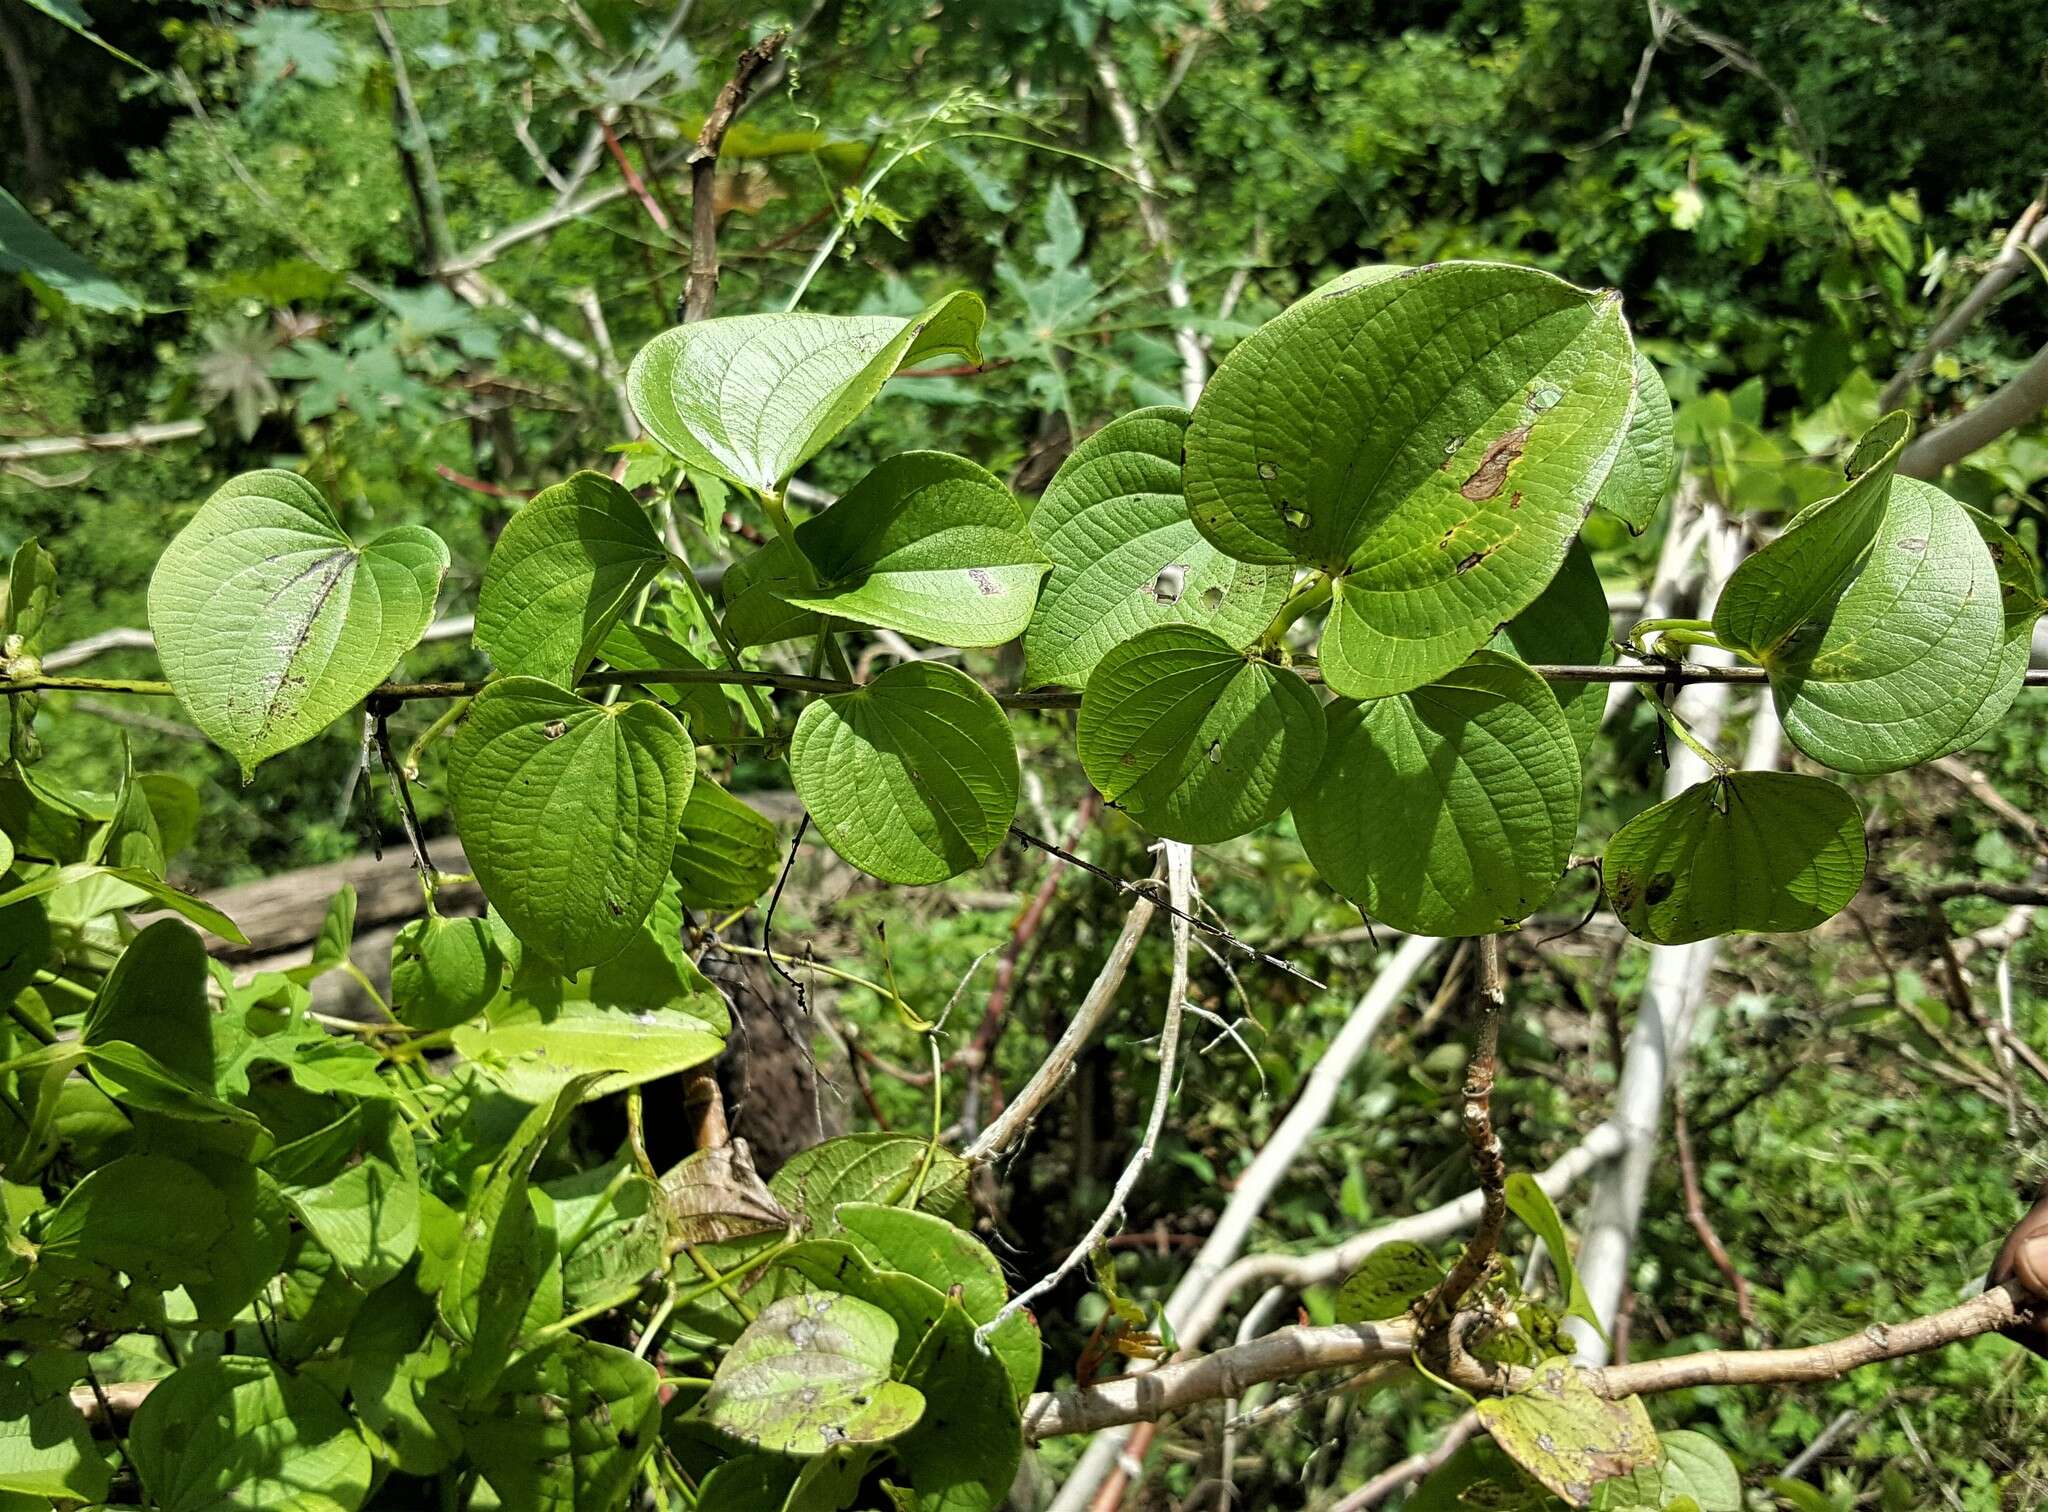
[788,662,1018,885]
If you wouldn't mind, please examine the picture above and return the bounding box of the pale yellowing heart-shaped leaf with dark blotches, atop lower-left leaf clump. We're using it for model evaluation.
[696,1293,929,1455]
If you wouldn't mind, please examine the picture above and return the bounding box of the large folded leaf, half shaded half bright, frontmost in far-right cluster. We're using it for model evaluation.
[1714,414,2005,772]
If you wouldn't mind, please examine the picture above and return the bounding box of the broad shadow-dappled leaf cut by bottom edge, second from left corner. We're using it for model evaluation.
[127,1354,371,1512]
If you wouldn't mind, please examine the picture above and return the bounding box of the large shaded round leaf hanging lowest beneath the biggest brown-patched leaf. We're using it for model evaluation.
[1294,652,1579,936]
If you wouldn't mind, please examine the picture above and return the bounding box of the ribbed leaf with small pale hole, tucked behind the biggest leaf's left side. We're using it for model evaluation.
[1024,406,1294,688]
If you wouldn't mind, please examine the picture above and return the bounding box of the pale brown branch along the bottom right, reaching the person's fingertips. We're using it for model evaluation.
[1024,1285,2032,1442]
